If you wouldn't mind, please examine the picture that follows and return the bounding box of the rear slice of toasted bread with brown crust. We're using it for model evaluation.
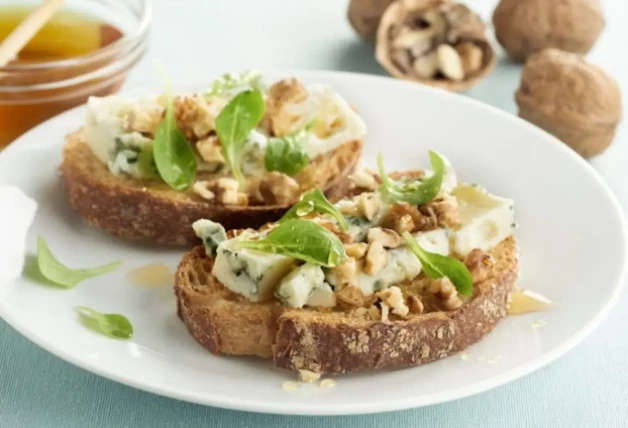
[61,131,362,245]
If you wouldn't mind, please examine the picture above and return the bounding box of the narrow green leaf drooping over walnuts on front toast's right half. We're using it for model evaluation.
[402,232,473,296]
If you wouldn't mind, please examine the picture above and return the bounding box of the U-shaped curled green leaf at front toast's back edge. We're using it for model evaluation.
[377,151,445,205]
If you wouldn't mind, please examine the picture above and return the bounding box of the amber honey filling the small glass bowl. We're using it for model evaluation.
[0,7,123,149]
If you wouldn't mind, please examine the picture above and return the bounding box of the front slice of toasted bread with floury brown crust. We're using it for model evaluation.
[175,236,518,373]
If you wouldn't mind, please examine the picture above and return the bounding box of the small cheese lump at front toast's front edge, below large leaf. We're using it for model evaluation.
[275,263,335,308]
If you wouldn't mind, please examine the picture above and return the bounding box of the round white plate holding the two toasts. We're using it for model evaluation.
[0,72,628,414]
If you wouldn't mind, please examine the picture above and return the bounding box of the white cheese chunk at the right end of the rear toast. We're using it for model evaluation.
[283,84,366,159]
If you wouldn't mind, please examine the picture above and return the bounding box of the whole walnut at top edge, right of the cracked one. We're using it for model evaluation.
[493,0,604,61]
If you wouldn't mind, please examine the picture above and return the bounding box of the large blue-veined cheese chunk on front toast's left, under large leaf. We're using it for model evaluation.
[212,239,295,302]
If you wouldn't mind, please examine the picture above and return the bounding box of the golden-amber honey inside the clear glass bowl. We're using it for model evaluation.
[0,7,124,149]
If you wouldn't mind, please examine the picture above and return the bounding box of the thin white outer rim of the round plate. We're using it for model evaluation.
[0,69,628,416]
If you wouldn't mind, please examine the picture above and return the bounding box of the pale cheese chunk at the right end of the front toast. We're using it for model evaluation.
[452,184,516,257]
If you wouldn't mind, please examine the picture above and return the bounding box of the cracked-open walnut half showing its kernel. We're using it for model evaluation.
[375,0,495,92]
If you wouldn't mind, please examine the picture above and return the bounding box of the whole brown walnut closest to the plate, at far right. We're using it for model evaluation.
[515,49,622,158]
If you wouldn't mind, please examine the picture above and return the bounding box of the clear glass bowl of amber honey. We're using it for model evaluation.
[0,0,151,149]
